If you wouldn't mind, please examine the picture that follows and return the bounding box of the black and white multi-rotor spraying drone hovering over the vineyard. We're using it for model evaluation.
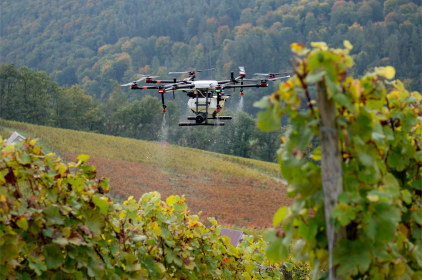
[121,66,290,126]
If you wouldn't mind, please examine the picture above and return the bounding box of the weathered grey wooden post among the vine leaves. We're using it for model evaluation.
[316,80,346,280]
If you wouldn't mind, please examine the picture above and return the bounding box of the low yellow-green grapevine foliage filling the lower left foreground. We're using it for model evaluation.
[0,139,308,279]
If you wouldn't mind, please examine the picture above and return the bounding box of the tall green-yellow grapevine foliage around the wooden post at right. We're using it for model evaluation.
[257,41,422,279]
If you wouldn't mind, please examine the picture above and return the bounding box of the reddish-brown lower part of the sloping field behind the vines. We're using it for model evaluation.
[61,152,292,228]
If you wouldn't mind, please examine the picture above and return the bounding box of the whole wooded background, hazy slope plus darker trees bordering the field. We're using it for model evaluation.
[0,0,422,161]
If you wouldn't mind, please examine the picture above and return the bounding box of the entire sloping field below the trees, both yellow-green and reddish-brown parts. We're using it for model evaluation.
[1,121,291,228]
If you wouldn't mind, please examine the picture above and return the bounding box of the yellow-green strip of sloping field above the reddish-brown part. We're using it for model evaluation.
[1,121,280,179]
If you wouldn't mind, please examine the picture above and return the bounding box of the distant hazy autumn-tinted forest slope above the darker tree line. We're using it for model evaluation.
[0,0,422,94]
